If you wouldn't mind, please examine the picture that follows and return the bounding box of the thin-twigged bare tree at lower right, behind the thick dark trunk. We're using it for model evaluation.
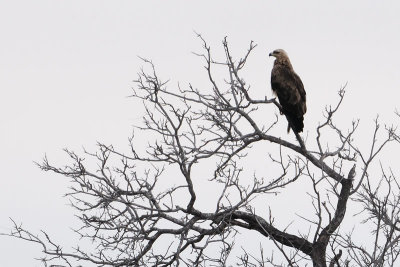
[338,123,400,267]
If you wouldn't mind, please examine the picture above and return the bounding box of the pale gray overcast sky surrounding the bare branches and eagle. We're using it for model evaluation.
[0,0,400,266]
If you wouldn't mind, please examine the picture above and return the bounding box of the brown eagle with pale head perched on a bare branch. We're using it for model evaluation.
[269,49,307,133]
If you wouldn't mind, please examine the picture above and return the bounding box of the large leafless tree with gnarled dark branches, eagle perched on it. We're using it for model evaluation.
[3,35,399,267]
